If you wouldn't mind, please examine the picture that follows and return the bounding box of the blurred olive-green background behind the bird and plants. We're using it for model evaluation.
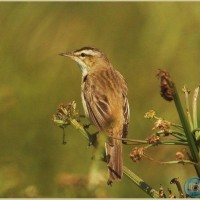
[0,2,200,197]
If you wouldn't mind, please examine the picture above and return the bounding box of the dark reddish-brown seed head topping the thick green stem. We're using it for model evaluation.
[157,69,174,101]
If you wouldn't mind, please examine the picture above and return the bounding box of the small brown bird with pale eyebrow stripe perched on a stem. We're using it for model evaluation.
[59,47,130,183]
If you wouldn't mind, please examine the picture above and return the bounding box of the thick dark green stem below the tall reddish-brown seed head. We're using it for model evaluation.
[169,83,200,177]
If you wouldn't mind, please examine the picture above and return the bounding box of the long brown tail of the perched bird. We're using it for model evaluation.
[105,138,123,184]
